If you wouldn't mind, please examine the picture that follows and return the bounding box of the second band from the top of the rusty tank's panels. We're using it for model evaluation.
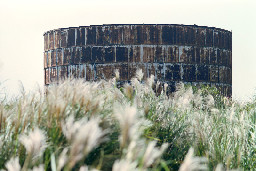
[44,45,232,68]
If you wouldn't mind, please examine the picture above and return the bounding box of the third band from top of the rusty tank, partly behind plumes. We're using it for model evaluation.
[45,63,232,85]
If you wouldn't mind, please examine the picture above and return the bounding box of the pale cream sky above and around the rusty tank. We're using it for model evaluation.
[0,0,256,99]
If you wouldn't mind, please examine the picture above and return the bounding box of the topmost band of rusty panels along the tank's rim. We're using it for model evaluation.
[44,25,232,51]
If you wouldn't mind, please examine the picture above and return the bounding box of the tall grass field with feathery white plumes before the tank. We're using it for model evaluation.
[0,70,256,171]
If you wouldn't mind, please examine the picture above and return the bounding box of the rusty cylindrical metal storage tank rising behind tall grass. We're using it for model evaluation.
[44,24,232,96]
